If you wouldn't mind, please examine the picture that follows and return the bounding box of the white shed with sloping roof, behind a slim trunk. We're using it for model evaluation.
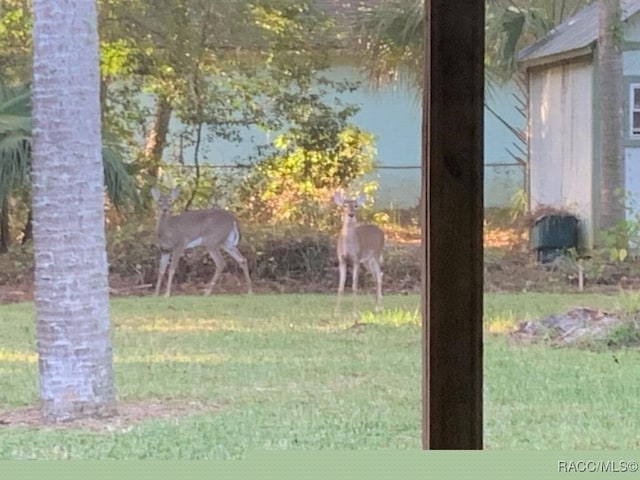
[518,0,640,248]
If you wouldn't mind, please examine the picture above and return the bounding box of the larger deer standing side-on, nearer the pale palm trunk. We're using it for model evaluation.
[151,187,251,297]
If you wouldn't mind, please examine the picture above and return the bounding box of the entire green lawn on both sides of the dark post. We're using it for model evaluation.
[0,293,640,459]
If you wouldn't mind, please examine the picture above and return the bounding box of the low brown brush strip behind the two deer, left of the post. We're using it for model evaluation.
[0,215,421,293]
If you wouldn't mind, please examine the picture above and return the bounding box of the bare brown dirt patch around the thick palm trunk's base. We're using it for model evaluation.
[0,400,223,432]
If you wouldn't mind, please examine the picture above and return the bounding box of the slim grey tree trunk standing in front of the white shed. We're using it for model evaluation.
[598,0,625,238]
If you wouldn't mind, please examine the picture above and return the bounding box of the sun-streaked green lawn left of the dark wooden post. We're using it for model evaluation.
[0,295,421,459]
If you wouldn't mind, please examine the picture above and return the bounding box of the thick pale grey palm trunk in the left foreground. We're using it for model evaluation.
[32,0,116,422]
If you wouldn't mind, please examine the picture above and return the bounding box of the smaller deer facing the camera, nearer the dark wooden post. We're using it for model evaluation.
[333,191,384,312]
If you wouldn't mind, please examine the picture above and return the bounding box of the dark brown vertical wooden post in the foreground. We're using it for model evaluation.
[422,0,485,449]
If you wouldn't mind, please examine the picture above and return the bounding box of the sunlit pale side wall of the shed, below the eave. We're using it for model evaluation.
[530,62,593,247]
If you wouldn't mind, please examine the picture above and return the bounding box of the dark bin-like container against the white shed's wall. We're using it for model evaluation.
[531,214,578,263]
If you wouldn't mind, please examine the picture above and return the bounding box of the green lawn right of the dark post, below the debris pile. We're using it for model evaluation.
[484,337,640,450]
